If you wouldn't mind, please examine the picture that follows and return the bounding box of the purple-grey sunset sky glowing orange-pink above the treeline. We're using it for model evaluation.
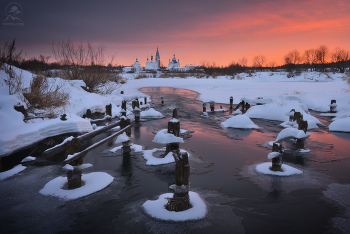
[0,0,350,66]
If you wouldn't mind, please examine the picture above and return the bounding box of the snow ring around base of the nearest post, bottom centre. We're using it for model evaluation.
[142,192,208,222]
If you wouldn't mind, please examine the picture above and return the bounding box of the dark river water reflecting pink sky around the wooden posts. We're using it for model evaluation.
[0,88,350,233]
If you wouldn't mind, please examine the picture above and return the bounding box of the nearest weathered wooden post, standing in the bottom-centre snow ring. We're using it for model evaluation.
[166,150,190,212]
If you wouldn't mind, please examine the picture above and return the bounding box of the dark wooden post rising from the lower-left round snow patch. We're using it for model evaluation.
[66,137,83,189]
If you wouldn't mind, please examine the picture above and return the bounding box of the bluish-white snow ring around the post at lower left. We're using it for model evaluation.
[39,172,114,200]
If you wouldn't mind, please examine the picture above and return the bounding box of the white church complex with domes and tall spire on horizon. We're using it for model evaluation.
[123,46,196,72]
